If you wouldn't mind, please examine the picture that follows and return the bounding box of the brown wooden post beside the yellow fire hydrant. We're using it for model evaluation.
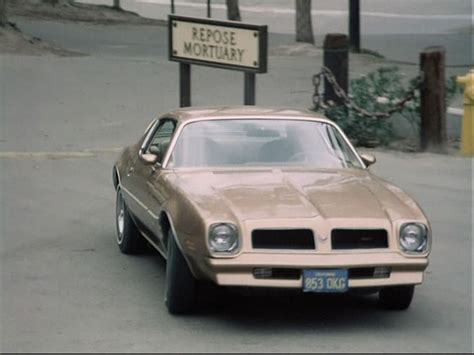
[420,47,446,152]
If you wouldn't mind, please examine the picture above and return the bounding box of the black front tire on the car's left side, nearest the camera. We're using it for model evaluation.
[165,231,197,314]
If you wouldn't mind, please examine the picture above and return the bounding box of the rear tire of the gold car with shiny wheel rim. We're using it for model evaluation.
[115,187,146,254]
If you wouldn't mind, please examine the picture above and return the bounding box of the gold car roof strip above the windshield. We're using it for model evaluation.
[161,106,330,122]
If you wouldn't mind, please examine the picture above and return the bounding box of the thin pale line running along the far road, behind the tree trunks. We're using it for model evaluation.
[137,0,474,22]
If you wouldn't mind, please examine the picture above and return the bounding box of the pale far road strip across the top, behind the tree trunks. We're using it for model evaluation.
[80,0,472,34]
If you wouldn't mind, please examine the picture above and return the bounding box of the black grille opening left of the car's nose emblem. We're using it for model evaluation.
[252,229,315,250]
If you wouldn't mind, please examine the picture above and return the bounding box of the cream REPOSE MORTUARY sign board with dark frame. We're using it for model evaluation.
[168,15,267,73]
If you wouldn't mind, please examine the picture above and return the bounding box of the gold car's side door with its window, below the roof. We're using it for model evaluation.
[127,118,176,246]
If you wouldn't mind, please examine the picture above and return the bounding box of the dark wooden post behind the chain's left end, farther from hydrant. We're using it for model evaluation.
[324,33,349,104]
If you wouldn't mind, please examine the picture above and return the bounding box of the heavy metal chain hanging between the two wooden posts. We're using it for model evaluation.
[313,67,423,119]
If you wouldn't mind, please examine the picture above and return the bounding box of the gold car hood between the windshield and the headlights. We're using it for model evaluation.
[168,169,424,221]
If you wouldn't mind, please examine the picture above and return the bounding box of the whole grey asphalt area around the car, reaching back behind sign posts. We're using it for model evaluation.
[0,13,473,352]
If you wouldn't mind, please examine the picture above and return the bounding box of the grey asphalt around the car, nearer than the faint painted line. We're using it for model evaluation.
[0,148,472,352]
